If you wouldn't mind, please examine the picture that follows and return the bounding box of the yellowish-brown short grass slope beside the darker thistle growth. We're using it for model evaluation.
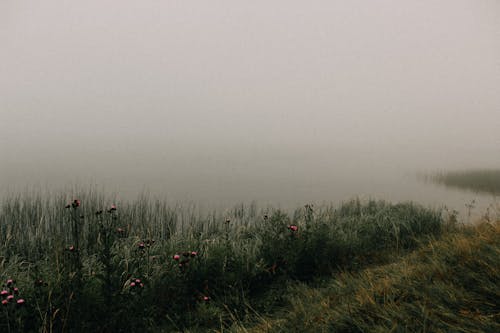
[246,221,500,332]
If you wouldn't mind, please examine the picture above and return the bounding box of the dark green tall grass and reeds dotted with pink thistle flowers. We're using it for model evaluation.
[0,193,443,332]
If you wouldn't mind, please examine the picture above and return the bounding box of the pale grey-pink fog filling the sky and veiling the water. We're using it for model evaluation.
[0,0,500,210]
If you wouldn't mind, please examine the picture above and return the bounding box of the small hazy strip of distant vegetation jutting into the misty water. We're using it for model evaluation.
[425,170,500,195]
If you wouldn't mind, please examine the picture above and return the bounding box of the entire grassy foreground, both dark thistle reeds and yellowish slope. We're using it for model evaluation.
[0,192,499,332]
